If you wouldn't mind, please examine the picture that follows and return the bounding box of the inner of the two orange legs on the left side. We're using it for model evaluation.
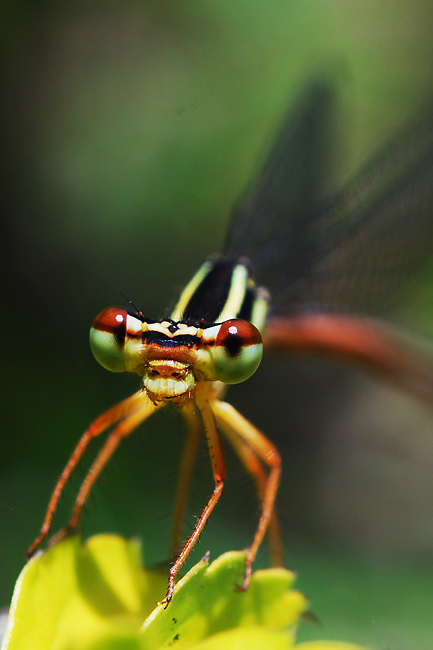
[50,393,164,545]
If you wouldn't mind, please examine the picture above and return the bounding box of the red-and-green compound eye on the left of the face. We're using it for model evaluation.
[90,307,128,372]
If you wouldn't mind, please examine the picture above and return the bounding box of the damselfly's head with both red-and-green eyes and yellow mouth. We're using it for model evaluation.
[90,307,263,403]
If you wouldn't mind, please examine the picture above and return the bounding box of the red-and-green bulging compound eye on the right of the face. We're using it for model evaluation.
[213,319,263,384]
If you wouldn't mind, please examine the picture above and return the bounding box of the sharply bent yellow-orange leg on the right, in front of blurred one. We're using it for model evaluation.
[212,400,281,590]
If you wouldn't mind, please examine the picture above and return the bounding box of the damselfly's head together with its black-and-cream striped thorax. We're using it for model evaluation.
[90,259,268,404]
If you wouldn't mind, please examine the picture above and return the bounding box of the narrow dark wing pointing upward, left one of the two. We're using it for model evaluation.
[224,82,334,292]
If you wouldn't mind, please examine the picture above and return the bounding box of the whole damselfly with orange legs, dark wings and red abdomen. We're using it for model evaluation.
[28,84,433,604]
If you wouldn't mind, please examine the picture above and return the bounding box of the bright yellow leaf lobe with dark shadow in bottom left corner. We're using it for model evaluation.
[2,535,167,650]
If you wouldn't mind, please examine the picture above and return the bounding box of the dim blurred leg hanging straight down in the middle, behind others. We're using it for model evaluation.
[171,404,203,557]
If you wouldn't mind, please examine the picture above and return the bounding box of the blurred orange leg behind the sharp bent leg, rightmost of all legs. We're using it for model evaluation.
[218,420,284,566]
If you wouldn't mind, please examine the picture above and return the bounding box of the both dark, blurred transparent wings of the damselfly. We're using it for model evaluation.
[226,79,433,314]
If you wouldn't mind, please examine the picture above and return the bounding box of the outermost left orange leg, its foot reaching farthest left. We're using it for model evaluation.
[27,390,159,559]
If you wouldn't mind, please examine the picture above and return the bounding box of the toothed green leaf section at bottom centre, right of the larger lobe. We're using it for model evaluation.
[143,552,307,650]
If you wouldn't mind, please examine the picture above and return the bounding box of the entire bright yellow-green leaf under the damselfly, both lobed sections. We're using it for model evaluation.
[2,535,368,650]
